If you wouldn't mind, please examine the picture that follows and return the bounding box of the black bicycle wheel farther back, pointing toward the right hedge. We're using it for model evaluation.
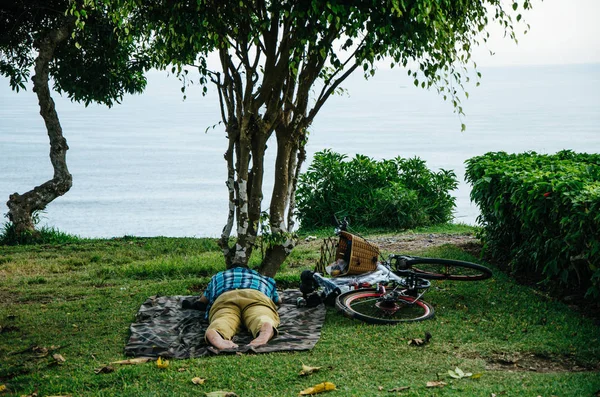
[398,258,492,281]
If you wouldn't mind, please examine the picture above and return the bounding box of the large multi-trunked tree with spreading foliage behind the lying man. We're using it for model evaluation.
[72,0,530,275]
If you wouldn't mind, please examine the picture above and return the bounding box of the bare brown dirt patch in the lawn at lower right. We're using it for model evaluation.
[465,353,600,373]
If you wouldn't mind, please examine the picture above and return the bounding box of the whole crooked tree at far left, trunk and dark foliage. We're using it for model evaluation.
[0,0,155,236]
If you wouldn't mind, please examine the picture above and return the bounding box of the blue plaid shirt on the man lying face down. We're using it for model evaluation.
[204,267,279,317]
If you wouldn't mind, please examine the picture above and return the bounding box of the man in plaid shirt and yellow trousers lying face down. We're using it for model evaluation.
[199,264,281,350]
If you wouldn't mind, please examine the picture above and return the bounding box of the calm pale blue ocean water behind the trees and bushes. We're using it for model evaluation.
[0,64,600,237]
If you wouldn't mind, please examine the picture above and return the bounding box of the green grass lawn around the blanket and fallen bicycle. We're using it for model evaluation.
[0,226,600,396]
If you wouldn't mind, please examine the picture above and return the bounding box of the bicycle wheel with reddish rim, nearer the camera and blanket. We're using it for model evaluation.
[335,288,433,324]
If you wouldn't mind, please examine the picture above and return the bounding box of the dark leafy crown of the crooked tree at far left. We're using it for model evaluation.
[0,0,151,106]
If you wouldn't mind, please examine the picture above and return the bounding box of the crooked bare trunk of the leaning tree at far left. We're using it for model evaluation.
[6,25,72,236]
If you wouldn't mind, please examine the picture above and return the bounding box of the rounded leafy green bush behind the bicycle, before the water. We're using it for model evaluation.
[296,150,457,230]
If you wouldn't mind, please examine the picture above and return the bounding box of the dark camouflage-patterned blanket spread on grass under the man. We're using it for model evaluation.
[125,290,326,358]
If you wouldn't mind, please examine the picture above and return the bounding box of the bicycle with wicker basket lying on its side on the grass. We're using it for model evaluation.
[301,219,492,324]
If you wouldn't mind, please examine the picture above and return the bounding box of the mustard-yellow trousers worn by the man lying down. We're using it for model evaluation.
[207,289,279,340]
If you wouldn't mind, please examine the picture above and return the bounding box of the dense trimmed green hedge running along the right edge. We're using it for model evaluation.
[466,151,600,298]
